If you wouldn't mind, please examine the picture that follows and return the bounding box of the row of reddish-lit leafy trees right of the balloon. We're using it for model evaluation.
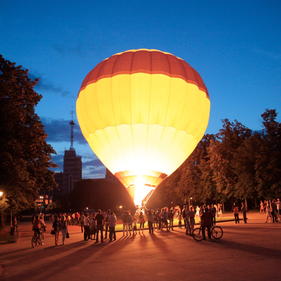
[149,109,281,206]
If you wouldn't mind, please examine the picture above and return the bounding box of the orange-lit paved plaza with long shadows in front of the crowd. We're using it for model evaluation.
[0,213,281,281]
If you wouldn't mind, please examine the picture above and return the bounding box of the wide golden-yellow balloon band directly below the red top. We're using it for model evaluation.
[77,73,210,133]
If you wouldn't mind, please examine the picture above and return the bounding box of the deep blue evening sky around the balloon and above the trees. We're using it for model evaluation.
[0,0,281,177]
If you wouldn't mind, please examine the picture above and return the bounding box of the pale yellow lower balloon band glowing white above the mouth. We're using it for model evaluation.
[87,124,197,175]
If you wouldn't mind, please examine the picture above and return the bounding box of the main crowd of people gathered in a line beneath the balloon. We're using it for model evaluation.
[29,205,222,246]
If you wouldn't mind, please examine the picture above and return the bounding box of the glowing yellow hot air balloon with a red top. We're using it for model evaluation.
[76,49,210,205]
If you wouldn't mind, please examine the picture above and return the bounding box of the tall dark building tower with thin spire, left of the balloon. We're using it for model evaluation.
[63,120,82,192]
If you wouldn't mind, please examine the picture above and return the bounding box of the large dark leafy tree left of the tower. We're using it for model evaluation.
[0,56,56,210]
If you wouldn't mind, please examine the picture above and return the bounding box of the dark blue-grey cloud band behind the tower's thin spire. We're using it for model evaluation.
[41,118,87,144]
